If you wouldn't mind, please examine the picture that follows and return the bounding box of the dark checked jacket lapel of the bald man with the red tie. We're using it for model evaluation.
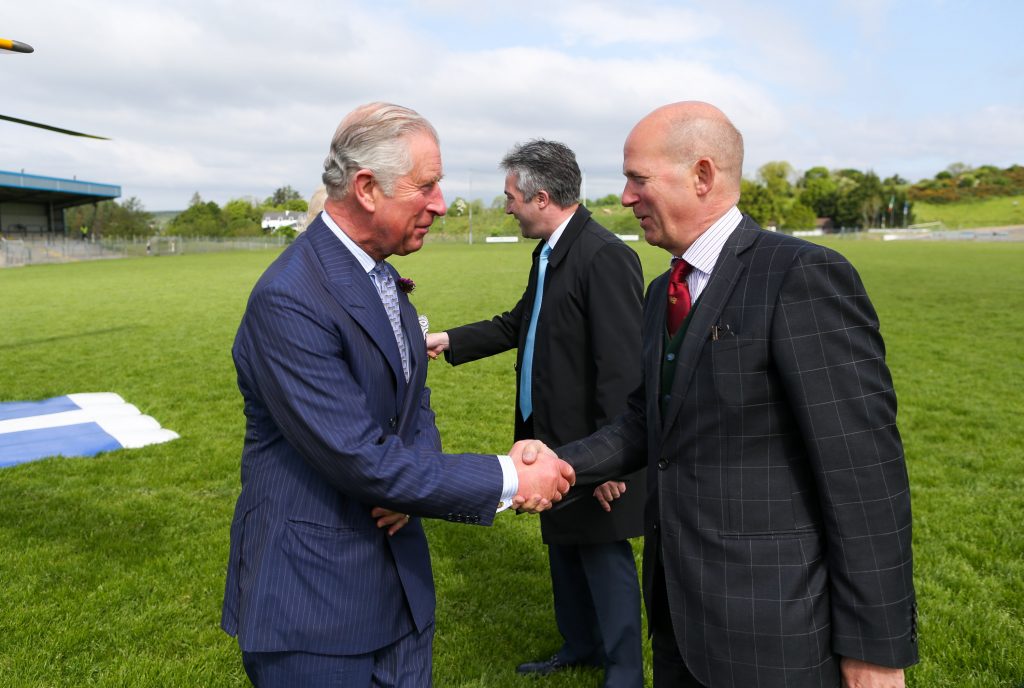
[662,220,760,440]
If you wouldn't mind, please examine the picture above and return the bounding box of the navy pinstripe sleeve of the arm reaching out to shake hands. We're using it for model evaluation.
[238,282,502,525]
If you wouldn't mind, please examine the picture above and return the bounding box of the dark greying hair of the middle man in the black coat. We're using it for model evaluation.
[501,138,583,208]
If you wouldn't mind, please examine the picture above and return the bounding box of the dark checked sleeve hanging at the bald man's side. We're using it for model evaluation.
[772,247,918,667]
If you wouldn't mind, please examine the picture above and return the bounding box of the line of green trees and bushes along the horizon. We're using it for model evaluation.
[65,161,1024,237]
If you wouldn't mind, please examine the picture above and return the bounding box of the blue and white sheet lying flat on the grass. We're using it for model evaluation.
[0,392,178,468]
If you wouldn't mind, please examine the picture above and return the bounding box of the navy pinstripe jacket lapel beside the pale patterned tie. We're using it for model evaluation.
[305,218,406,398]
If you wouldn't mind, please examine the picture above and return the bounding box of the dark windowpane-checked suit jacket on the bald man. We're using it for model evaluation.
[558,215,918,688]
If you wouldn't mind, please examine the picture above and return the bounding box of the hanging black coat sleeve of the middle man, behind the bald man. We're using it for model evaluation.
[587,242,643,427]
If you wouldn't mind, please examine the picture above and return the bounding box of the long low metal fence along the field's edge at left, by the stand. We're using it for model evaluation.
[0,237,288,267]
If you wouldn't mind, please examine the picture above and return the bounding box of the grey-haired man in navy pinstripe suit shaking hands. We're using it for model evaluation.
[221,102,572,688]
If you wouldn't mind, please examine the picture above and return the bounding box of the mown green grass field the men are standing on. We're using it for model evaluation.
[0,235,1024,688]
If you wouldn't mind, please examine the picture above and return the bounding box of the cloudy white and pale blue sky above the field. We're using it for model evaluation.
[0,0,1024,210]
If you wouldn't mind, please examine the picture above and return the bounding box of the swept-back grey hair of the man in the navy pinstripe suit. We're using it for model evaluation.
[323,102,438,201]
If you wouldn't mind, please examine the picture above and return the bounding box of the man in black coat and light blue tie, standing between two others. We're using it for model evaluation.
[427,140,645,688]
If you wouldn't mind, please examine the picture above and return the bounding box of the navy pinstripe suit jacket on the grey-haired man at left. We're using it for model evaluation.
[221,219,502,654]
